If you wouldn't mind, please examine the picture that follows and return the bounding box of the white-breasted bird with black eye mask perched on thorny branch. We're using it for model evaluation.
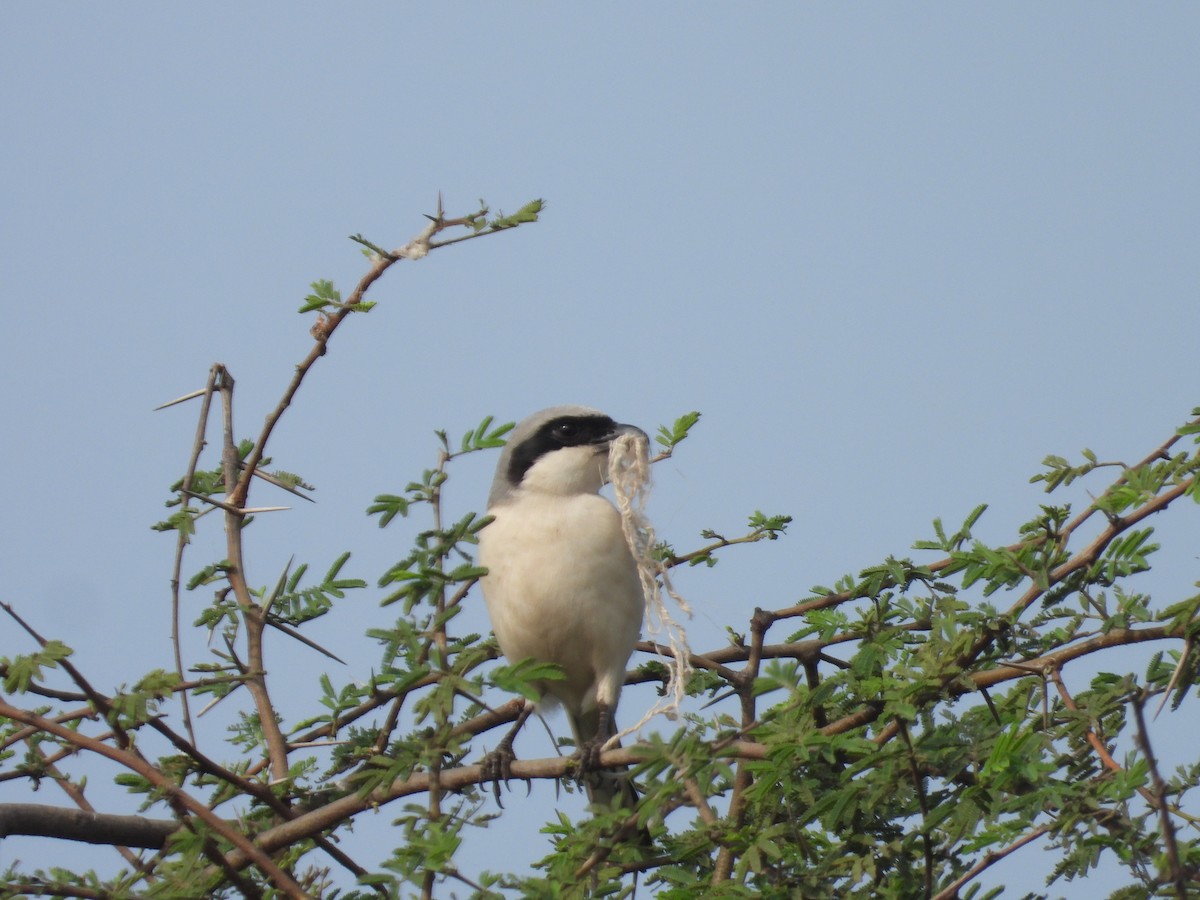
[479,406,646,808]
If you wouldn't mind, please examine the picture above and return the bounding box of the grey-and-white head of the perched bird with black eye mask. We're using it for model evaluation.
[487,406,646,509]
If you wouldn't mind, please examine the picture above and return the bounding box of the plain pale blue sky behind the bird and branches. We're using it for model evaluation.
[0,2,1200,898]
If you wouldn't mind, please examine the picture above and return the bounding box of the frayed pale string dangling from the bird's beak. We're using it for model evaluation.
[608,434,691,744]
